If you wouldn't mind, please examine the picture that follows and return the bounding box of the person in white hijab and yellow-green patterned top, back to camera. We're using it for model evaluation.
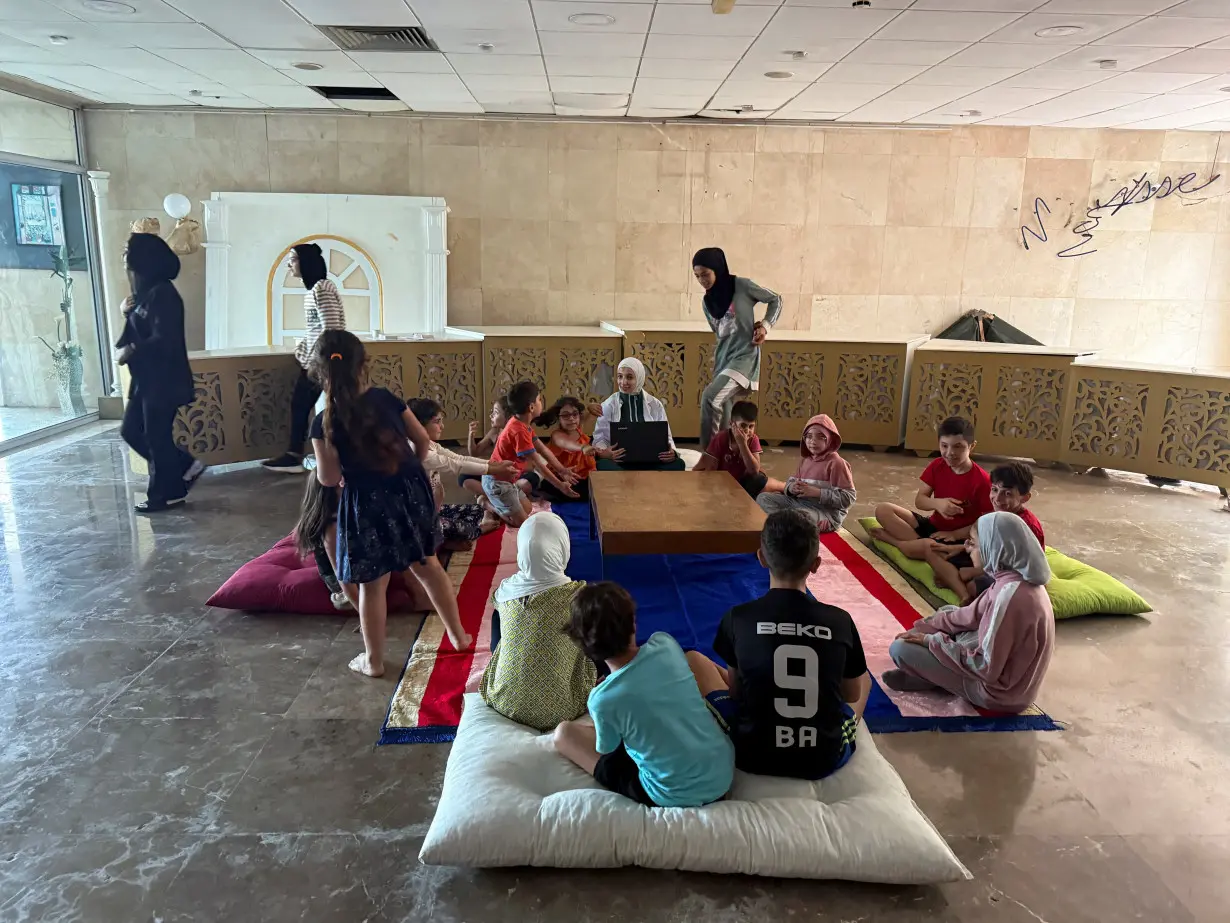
[478,513,598,731]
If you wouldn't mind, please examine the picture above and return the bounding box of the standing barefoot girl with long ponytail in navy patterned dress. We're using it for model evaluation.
[311,330,474,677]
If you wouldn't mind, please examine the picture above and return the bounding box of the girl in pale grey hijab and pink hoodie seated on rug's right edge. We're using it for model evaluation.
[882,512,1055,713]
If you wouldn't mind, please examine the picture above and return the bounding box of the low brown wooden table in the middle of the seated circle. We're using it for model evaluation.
[589,471,765,555]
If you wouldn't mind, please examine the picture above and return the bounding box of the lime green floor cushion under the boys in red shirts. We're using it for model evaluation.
[859,517,1153,619]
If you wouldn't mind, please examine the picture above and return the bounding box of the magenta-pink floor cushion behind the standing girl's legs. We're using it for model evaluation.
[207,535,432,615]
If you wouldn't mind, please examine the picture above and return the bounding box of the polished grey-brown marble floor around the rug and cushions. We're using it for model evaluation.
[0,431,1230,923]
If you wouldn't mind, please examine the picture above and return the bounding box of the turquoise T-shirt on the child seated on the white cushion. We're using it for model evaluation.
[589,631,733,807]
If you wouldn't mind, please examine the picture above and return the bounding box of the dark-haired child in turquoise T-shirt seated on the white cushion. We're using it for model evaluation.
[555,583,734,807]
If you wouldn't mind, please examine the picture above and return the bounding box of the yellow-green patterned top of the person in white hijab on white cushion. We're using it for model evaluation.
[478,581,598,731]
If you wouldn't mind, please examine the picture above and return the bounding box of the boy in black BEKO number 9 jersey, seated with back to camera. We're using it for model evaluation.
[688,509,871,779]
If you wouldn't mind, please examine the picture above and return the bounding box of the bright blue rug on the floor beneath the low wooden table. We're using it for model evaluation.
[553,503,1063,733]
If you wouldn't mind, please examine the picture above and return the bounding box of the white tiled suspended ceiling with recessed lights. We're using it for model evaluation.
[0,0,1230,130]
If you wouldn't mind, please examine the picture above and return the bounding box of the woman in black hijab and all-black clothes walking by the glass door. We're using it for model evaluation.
[116,234,205,513]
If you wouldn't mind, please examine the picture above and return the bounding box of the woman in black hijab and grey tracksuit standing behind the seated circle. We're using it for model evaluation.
[692,247,781,452]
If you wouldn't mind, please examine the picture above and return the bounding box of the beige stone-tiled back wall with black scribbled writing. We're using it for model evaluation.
[85,111,1230,367]
